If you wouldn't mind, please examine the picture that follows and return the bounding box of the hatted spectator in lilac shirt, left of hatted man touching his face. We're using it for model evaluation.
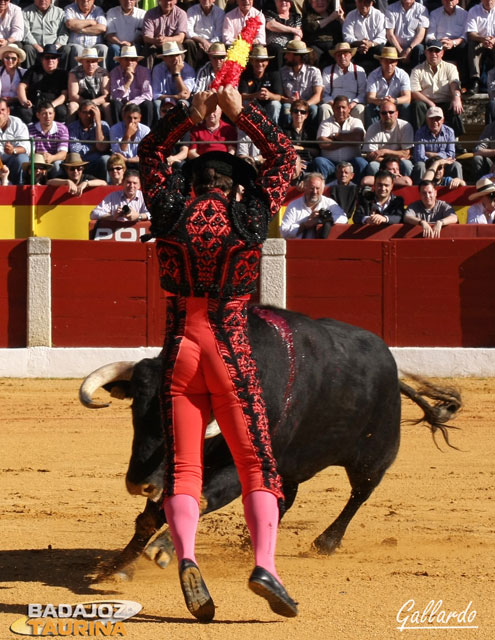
[110,45,153,126]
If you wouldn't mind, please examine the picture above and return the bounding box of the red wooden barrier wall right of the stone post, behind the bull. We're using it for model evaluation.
[287,234,495,347]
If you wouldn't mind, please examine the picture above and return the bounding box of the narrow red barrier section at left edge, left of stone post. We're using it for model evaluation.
[0,240,27,349]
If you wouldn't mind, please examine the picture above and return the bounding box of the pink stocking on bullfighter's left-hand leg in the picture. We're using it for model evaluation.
[163,494,199,564]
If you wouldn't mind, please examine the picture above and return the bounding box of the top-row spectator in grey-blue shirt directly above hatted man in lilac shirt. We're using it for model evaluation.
[105,0,146,70]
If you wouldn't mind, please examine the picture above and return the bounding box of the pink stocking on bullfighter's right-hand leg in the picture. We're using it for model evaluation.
[244,491,280,581]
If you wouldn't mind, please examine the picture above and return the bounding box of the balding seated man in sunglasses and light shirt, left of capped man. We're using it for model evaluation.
[363,101,414,176]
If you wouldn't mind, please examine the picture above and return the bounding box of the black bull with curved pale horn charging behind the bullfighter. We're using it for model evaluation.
[80,306,461,575]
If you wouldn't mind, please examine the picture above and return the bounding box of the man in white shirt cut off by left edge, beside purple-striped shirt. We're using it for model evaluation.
[0,98,29,184]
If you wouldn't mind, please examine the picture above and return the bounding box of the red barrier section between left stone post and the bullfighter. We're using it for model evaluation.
[52,240,165,347]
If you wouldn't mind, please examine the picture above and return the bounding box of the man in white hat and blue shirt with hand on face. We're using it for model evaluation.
[151,42,195,115]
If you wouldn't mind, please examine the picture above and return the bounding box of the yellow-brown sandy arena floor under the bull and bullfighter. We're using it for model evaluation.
[0,379,495,640]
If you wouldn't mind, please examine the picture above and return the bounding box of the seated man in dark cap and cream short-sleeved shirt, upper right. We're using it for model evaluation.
[411,40,464,136]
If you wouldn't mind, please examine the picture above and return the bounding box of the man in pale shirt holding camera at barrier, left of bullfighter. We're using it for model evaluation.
[90,169,150,222]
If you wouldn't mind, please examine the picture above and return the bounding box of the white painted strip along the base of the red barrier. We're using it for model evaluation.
[0,347,495,378]
